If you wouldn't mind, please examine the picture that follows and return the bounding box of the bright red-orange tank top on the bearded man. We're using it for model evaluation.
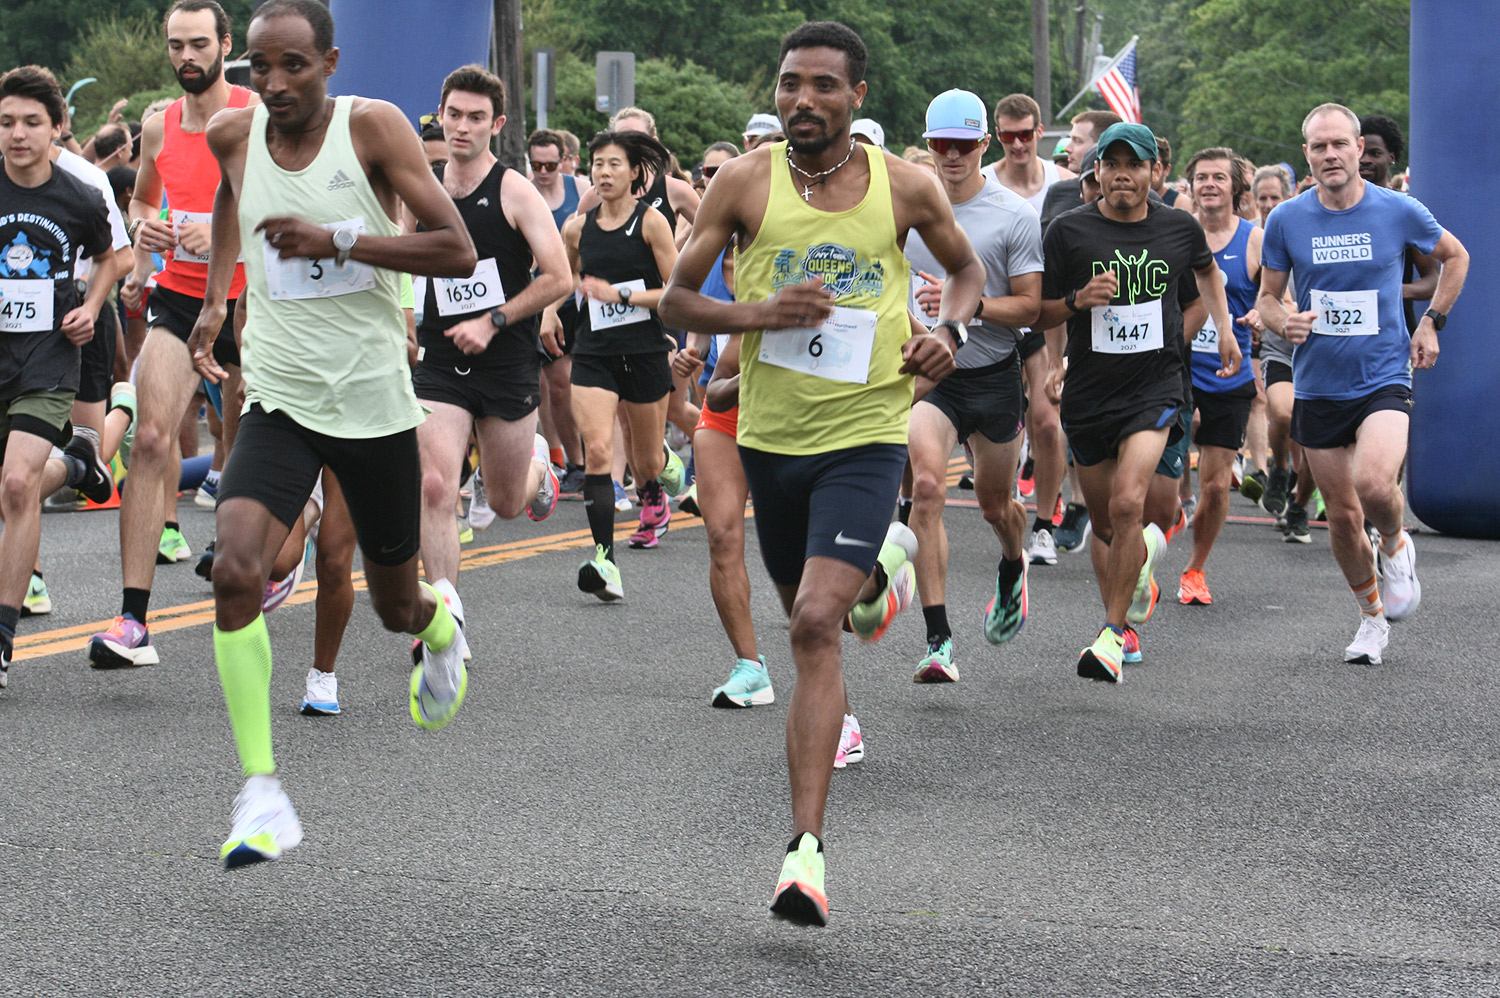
[156,87,251,299]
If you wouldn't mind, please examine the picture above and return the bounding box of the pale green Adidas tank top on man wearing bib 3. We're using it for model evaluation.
[240,96,422,440]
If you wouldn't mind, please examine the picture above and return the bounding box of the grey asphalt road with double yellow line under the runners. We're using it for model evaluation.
[0,468,1500,996]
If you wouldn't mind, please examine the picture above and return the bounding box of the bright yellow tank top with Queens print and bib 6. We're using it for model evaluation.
[735,143,912,455]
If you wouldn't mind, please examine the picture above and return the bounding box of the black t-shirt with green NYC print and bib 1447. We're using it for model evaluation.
[1041,203,1214,426]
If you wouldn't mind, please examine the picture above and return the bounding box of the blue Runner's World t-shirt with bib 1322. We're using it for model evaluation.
[1260,183,1443,399]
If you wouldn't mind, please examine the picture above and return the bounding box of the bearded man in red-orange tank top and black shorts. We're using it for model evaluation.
[89,0,255,668]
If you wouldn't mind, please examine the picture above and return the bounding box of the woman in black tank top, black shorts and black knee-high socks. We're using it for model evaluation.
[563,132,683,600]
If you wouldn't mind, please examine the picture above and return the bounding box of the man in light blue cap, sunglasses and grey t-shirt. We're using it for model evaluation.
[906,90,1041,683]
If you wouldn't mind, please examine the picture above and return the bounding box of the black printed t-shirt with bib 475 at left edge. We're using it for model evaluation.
[0,165,111,399]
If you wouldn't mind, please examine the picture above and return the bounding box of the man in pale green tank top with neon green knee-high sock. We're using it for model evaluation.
[192,0,477,867]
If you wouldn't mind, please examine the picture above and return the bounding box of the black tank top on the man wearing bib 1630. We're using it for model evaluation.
[417,162,539,369]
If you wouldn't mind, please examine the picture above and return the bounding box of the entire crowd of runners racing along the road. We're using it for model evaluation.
[0,0,1469,924]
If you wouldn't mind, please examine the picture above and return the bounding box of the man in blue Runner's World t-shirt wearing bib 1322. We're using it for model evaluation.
[1257,104,1469,665]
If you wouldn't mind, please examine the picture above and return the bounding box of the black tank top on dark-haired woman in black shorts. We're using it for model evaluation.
[573,198,674,356]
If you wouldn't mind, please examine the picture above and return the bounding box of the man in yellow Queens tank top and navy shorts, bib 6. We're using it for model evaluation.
[659,21,984,924]
